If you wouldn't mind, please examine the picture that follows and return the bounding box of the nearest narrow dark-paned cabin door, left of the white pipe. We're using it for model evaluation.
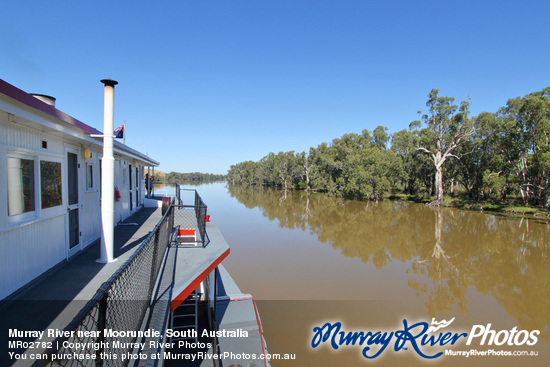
[67,152,80,258]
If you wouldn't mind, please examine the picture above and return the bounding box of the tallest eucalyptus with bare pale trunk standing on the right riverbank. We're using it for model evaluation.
[416,89,474,205]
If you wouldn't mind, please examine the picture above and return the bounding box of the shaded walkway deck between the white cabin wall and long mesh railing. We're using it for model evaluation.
[0,208,162,366]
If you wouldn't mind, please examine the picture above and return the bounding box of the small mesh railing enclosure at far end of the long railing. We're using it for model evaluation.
[174,185,209,247]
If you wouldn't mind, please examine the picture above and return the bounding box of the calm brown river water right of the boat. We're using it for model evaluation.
[162,183,550,367]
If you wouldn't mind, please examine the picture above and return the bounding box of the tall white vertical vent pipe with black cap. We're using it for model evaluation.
[97,79,118,263]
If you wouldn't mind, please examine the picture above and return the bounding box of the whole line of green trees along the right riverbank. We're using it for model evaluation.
[227,87,550,209]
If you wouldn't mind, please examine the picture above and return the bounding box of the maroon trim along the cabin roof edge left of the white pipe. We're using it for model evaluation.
[0,79,101,134]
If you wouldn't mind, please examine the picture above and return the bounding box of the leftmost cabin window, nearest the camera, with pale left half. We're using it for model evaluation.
[7,157,35,216]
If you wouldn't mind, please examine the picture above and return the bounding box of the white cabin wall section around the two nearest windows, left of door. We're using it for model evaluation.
[0,111,67,299]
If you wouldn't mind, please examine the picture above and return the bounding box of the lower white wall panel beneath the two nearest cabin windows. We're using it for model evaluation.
[0,214,67,299]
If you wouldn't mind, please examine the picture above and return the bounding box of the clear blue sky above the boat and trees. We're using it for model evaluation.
[0,0,550,173]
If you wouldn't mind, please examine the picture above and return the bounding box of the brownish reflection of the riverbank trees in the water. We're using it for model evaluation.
[229,186,550,340]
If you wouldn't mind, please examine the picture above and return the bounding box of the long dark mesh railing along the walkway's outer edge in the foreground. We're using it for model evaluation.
[32,201,174,367]
